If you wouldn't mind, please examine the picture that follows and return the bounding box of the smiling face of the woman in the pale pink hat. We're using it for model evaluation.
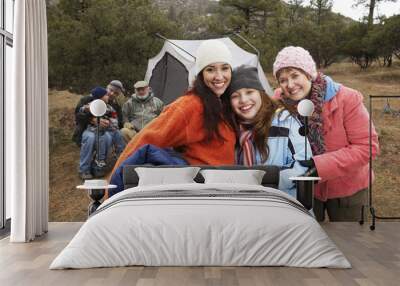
[278,68,311,101]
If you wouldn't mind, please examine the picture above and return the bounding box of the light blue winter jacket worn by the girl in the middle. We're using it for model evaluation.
[256,110,312,198]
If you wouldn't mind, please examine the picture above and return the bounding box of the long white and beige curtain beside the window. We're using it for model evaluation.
[5,0,49,242]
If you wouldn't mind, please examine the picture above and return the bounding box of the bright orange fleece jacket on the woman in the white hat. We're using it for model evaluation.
[113,93,236,173]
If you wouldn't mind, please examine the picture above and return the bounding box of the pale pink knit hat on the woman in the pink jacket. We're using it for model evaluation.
[273,46,317,79]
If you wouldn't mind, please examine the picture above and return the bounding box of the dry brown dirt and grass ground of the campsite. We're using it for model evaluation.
[49,62,400,221]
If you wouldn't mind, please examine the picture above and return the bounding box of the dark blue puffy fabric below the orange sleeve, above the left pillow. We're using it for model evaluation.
[108,144,188,197]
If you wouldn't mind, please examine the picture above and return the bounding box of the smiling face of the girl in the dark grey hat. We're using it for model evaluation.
[231,88,262,122]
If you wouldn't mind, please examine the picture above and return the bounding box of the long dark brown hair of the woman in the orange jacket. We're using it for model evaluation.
[192,72,233,142]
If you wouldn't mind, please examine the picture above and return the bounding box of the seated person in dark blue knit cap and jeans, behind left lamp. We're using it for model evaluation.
[76,87,125,180]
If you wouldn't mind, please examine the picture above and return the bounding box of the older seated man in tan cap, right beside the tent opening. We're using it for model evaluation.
[121,80,164,143]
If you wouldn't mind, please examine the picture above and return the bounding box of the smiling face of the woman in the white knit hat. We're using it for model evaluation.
[202,63,232,97]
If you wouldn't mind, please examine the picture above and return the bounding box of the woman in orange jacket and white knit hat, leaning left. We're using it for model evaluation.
[114,40,235,174]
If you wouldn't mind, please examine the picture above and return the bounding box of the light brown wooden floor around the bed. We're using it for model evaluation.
[0,222,400,286]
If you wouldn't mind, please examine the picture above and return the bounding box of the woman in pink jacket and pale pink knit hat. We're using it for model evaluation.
[273,47,379,221]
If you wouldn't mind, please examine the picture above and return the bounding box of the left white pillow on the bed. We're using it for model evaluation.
[135,167,200,186]
